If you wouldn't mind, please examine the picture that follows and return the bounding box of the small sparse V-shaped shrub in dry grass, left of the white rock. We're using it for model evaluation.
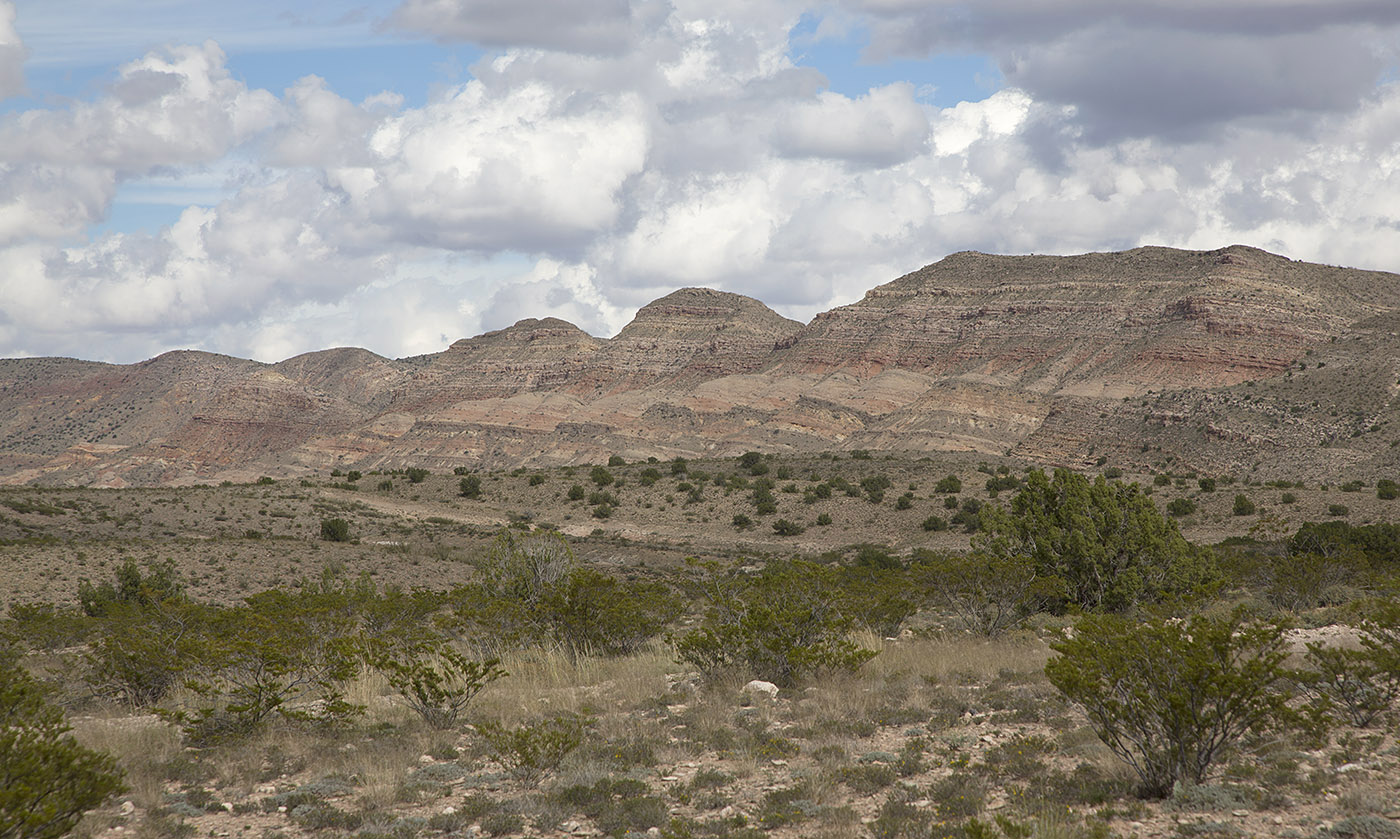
[365,644,507,728]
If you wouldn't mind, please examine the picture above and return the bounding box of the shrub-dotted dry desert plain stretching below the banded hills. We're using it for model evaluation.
[8,451,1400,839]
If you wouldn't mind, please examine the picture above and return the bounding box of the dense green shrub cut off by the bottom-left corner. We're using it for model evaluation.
[0,649,123,839]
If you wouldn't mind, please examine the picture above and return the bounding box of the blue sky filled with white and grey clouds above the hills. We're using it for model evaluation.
[0,0,1400,363]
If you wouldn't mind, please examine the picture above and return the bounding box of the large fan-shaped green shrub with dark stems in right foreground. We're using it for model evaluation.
[1046,611,1291,798]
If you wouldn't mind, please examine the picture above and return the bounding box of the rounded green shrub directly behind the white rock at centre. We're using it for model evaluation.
[672,560,875,685]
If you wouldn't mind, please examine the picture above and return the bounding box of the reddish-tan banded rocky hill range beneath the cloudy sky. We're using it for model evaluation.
[0,245,1400,485]
